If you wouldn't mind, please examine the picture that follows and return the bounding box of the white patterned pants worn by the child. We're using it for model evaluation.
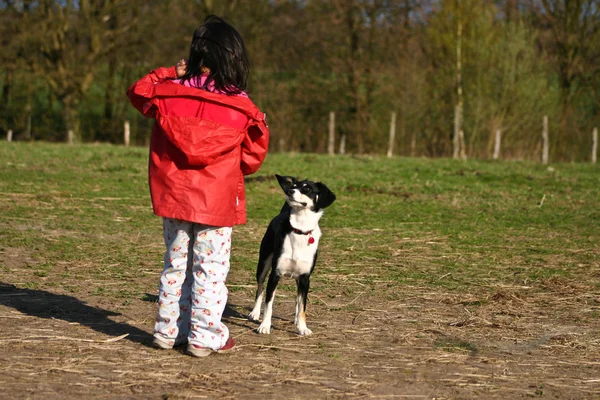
[154,218,232,350]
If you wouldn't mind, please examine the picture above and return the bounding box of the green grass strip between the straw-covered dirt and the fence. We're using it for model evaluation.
[0,142,600,298]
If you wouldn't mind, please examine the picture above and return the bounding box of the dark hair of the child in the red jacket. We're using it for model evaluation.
[181,15,250,94]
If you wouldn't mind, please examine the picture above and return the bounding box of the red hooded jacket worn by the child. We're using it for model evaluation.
[127,67,269,226]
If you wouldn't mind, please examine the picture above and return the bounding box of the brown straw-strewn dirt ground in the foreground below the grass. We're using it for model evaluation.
[0,242,600,399]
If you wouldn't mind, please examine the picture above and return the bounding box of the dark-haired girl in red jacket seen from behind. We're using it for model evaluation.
[127,16,269,357]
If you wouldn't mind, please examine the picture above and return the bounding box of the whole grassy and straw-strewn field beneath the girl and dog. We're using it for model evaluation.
[0,145,600,399]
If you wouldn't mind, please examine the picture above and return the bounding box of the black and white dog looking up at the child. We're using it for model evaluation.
[248,175,335,335]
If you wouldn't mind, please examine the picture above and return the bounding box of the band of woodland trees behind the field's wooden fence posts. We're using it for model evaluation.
[0,0,600,160]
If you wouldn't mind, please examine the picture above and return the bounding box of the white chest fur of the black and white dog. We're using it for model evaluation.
[277,227,321,278]
